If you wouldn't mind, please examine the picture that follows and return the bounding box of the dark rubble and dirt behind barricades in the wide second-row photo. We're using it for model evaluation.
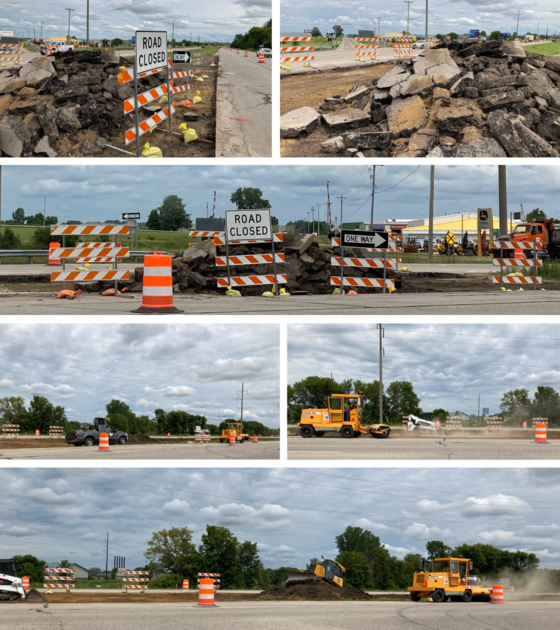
[70,234,560,296]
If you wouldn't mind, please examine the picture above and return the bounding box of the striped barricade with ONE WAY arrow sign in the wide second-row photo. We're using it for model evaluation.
[330,230,400,293]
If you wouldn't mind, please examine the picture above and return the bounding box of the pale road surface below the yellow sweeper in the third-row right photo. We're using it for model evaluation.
[288,436,560,460]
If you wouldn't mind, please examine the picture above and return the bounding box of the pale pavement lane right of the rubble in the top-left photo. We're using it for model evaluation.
[216,49,272,157]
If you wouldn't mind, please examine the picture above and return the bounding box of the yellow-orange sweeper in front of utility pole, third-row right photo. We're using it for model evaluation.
[298,392,391,438]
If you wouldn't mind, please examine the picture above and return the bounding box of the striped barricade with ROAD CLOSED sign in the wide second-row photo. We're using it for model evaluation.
[214,215,288,297]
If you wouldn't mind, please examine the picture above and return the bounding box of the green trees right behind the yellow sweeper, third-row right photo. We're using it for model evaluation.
[288,376,422,424]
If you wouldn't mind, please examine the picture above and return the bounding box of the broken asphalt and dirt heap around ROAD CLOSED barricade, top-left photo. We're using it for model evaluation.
[0,50,217,157]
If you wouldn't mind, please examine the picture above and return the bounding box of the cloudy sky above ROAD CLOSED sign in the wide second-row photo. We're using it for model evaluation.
[2,165,560,224]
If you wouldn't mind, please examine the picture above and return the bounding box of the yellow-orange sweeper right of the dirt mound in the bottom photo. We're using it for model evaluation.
[408,557,492,603]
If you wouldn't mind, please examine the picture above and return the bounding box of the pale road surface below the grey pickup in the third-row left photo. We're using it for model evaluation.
[0,441,280,462]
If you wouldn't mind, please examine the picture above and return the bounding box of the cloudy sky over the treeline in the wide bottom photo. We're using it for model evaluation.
[0,468,560,569]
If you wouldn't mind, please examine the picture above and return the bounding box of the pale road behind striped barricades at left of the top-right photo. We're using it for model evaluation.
[281,37,400,74]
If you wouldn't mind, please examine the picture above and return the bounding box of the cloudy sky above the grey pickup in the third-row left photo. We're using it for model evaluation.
[0,324,279,430]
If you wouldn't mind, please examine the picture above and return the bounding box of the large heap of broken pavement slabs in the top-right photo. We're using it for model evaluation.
[280,41,560,158]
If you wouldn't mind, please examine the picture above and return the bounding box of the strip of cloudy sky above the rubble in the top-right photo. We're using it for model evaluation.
[281,0,560,35]
